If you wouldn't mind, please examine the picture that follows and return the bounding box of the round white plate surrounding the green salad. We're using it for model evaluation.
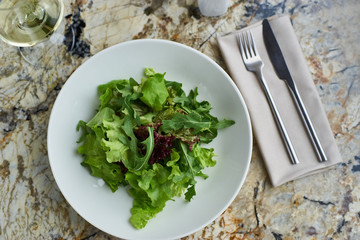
[47,39,252,240]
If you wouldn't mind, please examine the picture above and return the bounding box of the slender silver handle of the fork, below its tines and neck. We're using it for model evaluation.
[256,69,299,164]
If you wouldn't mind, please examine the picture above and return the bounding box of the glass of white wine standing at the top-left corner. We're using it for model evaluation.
[0,0,64,68]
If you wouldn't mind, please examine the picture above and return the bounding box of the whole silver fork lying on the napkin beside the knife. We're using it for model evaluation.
[237,31,299,164]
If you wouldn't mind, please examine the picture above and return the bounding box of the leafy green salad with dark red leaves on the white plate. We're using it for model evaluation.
[77,68,234,229]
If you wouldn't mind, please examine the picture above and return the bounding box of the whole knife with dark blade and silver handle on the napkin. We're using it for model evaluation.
[262,19,327,162]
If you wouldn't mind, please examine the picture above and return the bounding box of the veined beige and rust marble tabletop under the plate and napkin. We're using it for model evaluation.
[0,0,360,240]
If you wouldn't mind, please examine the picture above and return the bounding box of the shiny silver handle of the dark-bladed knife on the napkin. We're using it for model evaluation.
[288,84,327,162]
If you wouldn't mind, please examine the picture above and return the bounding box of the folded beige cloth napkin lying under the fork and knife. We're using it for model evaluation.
[218,16,341,187]
